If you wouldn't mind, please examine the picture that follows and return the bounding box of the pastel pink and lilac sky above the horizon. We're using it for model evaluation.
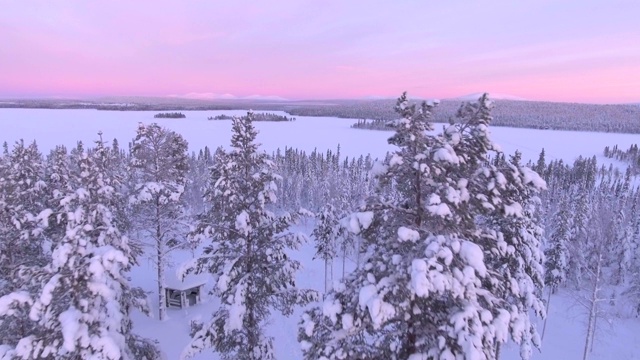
[0,0,640,103]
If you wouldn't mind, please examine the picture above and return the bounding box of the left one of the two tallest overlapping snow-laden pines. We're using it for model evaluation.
[298,93,444,359]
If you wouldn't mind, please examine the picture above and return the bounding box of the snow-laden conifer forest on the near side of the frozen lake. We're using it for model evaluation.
[0,94,640,360]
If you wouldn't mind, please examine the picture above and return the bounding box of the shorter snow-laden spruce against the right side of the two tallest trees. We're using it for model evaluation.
[482,152,546,359]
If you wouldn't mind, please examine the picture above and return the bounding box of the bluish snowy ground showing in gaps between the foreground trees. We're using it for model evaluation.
[132,222,640,360]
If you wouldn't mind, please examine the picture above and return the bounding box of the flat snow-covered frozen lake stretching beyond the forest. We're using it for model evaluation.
[0,109,640,161]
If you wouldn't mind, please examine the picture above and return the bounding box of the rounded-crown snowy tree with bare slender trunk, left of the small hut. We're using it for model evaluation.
[129,124,188,320]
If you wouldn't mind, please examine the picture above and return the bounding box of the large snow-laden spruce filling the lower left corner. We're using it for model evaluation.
[0,136,158,360]
